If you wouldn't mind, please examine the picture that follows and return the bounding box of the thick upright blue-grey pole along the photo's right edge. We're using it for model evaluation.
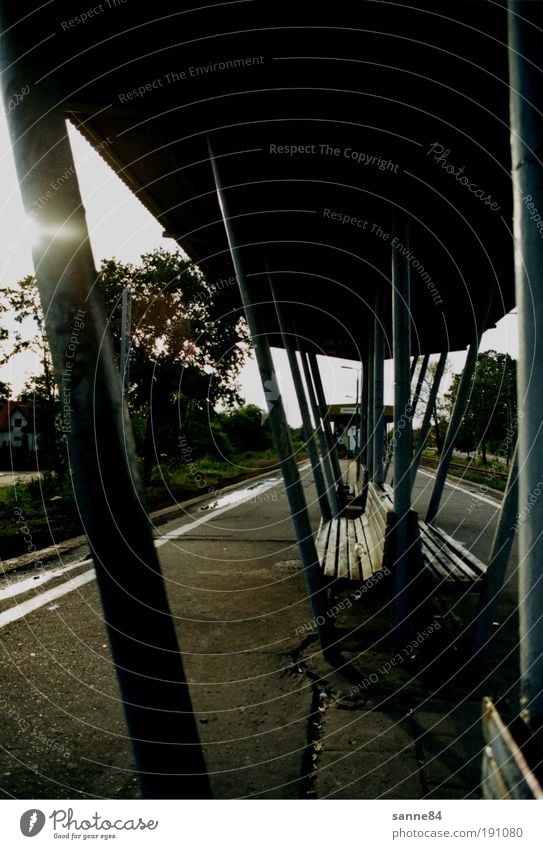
[509,0,543,728]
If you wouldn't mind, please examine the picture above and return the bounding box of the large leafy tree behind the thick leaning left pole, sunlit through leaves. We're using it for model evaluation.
[0,250,248,482]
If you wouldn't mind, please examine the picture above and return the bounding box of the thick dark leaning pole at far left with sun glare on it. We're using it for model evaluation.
[2,39,210,798]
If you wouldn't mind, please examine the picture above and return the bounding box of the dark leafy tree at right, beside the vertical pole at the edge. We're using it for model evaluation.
[445,351,517,465]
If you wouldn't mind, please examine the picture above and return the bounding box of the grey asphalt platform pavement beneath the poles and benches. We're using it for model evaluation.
[0,460,518,799]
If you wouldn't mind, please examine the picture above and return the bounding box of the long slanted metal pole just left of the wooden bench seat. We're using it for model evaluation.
[208,140,337,660]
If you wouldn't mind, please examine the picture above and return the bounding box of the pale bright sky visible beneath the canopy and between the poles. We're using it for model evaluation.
[0,108,518,426]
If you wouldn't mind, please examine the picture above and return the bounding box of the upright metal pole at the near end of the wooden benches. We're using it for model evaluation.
[392,219,411,642]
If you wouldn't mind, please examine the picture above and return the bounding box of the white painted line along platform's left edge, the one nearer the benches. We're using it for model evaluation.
[0,464,296,628]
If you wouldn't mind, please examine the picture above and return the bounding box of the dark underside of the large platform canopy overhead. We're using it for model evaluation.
[3,0,514,358]
